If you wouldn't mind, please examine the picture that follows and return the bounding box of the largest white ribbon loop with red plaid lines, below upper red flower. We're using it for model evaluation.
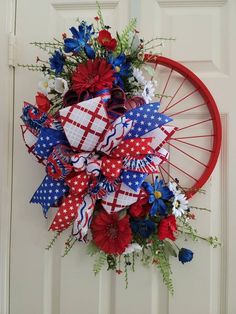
[60,97,110,151]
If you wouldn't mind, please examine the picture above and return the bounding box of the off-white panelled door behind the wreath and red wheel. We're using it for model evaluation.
[0,0,236,314]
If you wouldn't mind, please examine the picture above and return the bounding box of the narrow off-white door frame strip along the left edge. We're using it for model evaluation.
[0,0,16,314]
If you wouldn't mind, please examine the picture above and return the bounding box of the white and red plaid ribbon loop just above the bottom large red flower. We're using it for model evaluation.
[102,183,140,214]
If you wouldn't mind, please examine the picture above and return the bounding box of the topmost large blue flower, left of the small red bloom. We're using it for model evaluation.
[64,21,95,59]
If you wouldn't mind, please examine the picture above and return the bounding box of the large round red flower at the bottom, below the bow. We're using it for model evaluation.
[91,210,132,254]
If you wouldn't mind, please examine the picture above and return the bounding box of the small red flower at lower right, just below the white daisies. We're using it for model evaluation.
[158,215,177,241]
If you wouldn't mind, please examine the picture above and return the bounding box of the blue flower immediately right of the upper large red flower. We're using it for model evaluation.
[108,53,131,88]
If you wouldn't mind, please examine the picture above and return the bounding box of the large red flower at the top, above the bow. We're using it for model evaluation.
[72,58,115,95]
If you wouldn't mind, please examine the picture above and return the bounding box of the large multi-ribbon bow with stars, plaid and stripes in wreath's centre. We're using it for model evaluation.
[23,97,175,241]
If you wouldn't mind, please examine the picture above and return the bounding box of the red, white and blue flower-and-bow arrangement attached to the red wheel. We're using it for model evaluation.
[21,7,219,292]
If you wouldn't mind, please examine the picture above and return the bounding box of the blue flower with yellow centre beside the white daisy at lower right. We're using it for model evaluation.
[143,178,174,216]
